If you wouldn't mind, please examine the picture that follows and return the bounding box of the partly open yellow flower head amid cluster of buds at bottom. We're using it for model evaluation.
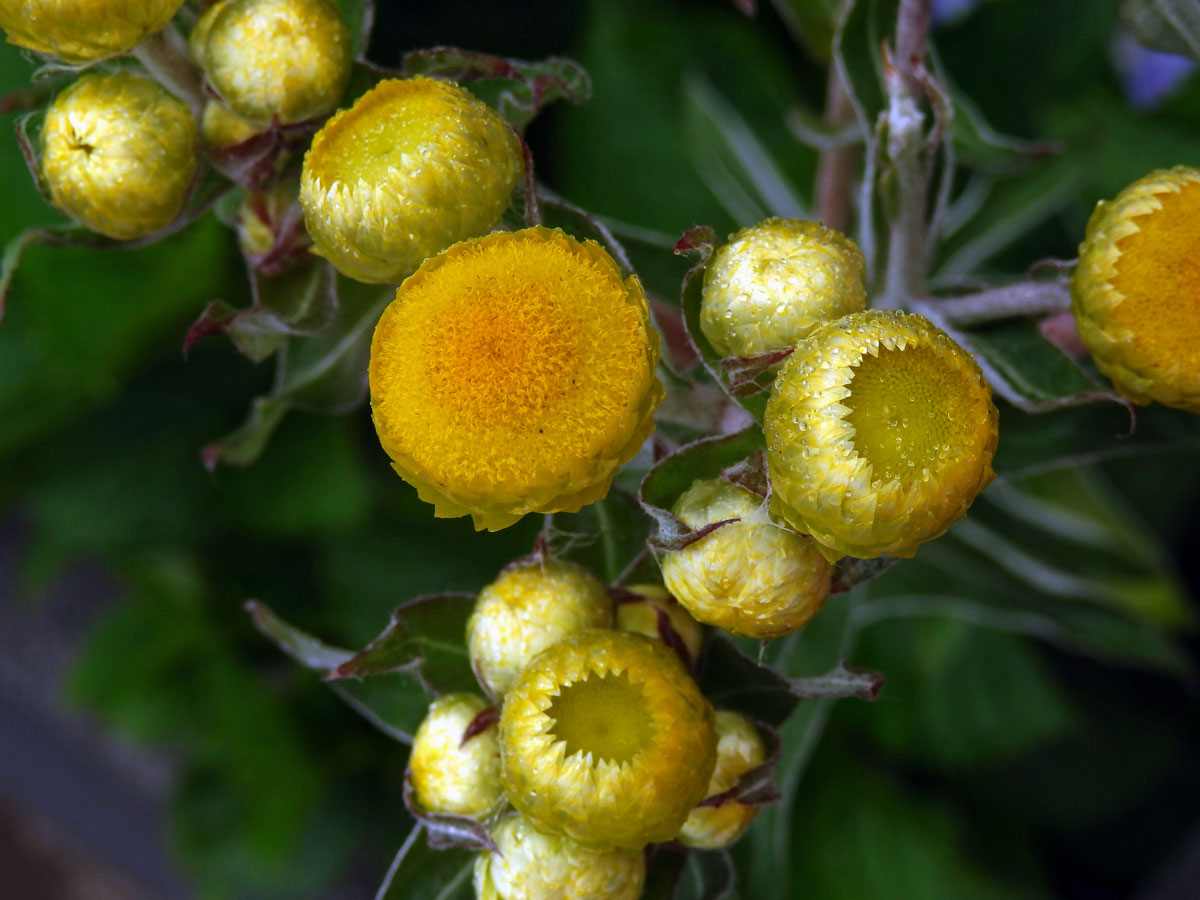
[500,631,716,850]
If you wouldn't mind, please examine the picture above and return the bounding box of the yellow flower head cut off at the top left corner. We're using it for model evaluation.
[0,0,184,62]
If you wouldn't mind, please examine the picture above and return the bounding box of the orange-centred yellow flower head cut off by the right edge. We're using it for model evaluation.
[1070,166,1200,413]
